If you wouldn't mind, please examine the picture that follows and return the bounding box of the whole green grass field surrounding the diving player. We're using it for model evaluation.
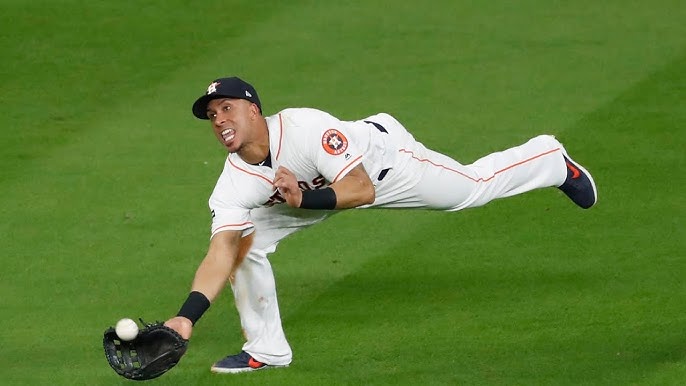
[0,0,686,385]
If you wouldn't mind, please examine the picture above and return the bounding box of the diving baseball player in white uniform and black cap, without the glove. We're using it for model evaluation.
[166,77,597,373]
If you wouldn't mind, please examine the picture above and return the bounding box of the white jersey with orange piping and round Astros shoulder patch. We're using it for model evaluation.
[209,108,396,235]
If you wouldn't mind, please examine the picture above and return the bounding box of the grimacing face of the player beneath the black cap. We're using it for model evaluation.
[207,98,252,153]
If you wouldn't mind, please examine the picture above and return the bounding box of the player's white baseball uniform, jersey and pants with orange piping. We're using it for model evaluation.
[209,108,567,365]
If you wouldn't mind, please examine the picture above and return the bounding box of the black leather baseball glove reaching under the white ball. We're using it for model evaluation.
[102,319,188,381]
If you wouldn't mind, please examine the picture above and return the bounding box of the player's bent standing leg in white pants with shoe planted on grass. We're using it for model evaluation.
[212,205,330,373]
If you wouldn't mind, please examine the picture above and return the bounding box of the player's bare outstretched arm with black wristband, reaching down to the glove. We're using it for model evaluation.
[165,231,245,339]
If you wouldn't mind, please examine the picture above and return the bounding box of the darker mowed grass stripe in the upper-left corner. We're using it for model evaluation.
[0,0,295,187]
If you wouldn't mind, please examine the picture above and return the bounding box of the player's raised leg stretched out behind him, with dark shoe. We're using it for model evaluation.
[372,121,597,210]
